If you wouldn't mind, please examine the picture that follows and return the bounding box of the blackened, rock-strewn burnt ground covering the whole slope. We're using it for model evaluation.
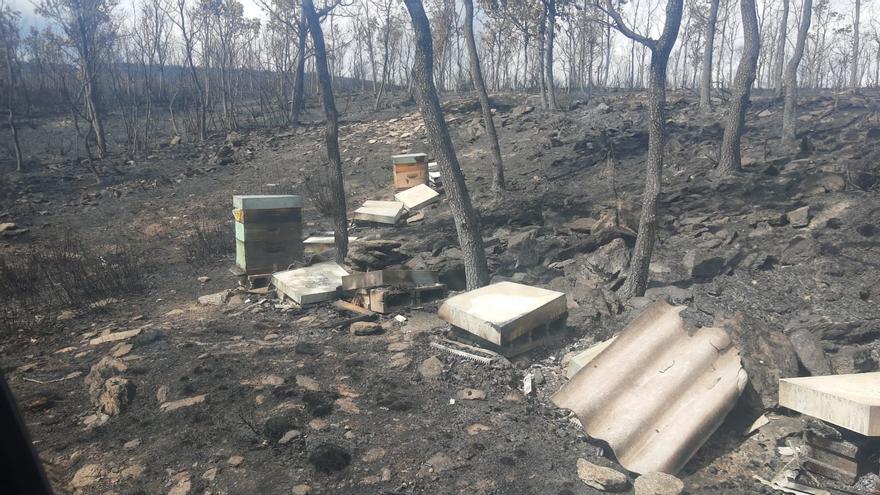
[0,93,880,495]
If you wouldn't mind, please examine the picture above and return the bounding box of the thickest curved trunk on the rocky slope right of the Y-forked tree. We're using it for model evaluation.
[718,0,761,175]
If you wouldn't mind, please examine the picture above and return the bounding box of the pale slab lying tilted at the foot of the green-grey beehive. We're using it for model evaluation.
[271,261,348,304]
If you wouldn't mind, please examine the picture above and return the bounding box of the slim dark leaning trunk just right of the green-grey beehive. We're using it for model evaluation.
[302,0,348,263]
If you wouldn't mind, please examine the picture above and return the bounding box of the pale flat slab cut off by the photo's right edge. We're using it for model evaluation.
[779,372,880,437]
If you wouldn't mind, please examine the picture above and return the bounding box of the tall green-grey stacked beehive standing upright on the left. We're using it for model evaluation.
[232,195,303,275]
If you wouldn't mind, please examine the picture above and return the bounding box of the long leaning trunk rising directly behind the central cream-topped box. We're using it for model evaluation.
[404,0,489,289]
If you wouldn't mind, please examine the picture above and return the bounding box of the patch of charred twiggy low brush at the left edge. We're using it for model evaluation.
[0,233,145,333]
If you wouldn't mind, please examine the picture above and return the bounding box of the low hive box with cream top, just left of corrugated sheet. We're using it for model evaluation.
[439,282,568,356]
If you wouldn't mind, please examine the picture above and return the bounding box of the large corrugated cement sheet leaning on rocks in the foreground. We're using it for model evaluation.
[553,301,748,474]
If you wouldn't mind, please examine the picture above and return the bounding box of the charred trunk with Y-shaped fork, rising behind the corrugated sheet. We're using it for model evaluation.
[605,0,684,299]
